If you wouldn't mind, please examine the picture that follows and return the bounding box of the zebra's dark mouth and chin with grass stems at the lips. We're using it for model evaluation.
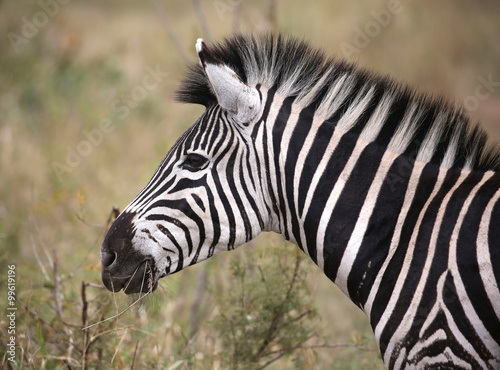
[102,259,158,294]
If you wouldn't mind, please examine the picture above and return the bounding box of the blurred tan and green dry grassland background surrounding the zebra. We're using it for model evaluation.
[0,0,500,369]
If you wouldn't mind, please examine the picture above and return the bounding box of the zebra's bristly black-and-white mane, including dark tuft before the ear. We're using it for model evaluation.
[176,34,500,170]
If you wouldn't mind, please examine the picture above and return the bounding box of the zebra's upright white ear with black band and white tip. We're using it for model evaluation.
[196,39,261,126]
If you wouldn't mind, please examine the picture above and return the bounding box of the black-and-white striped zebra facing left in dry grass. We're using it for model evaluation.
[101,34,500,369]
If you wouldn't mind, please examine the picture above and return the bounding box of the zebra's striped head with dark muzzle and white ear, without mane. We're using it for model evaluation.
[101,39,268,294]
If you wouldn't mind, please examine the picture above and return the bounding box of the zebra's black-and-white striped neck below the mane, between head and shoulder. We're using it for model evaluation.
[267,93,498,307]
